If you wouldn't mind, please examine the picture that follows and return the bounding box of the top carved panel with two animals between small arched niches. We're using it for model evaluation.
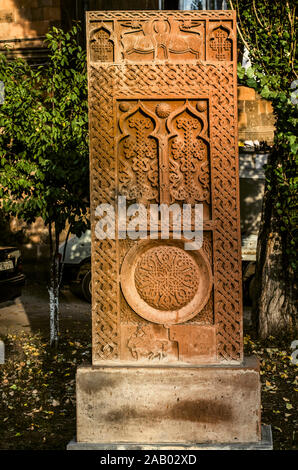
[89,12,235,63]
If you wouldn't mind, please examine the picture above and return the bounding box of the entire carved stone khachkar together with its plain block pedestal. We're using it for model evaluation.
[70,11,270,452]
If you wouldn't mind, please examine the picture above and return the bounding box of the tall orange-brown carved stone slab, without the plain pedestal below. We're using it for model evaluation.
[87,11,242,364]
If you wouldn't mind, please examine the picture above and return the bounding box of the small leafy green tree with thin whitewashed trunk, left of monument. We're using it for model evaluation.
[0,26,89,345]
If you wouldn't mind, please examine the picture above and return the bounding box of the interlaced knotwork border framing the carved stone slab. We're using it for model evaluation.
[88,11,243,364]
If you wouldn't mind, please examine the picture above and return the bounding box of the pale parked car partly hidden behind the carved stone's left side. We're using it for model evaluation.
[59,230,91,302]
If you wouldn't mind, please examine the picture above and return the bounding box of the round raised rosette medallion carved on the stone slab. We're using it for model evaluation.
[121,240,212,325]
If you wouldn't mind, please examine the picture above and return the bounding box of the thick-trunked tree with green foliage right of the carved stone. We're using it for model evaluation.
[230,0,298,337]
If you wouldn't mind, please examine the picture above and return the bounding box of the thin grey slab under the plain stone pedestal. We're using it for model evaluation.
[67,424,273,451]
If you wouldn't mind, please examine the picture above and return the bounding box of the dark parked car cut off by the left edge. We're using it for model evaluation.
[0,247,25,302]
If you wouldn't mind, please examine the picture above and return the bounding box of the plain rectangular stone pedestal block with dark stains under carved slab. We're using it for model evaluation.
[77,357,261,446]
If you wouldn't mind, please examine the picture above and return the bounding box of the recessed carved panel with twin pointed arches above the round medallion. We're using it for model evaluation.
[118,99,210,210]
